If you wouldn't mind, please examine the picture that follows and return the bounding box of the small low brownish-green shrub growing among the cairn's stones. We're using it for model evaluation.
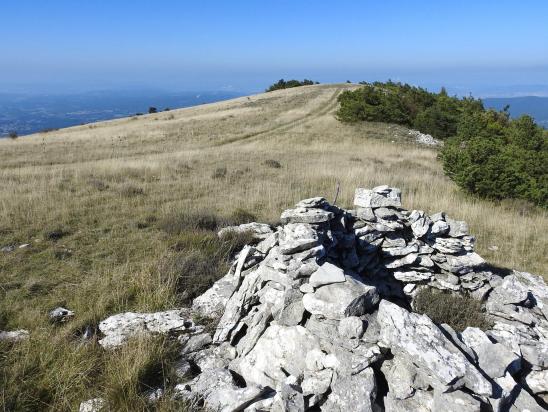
[413,287,491,332]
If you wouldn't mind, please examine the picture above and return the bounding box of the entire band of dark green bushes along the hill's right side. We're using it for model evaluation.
[337,82,548,207]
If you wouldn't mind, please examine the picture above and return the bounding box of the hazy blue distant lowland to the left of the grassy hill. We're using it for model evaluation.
[0,91,241,137]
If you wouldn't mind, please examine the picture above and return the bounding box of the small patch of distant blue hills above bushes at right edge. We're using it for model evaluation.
[482,96,548,129]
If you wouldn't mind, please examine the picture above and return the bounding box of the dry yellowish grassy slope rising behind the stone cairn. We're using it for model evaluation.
[0,85,548,410]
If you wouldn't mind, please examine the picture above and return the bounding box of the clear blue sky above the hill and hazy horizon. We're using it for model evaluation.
[0,0,548,94]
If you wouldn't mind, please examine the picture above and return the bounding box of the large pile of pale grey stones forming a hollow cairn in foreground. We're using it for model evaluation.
[91,186,548,412]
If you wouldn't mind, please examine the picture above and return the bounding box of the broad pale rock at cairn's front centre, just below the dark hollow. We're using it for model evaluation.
[303,275,379,319]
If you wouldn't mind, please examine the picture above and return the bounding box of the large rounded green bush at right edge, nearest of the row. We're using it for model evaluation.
[440,111,548,207]
